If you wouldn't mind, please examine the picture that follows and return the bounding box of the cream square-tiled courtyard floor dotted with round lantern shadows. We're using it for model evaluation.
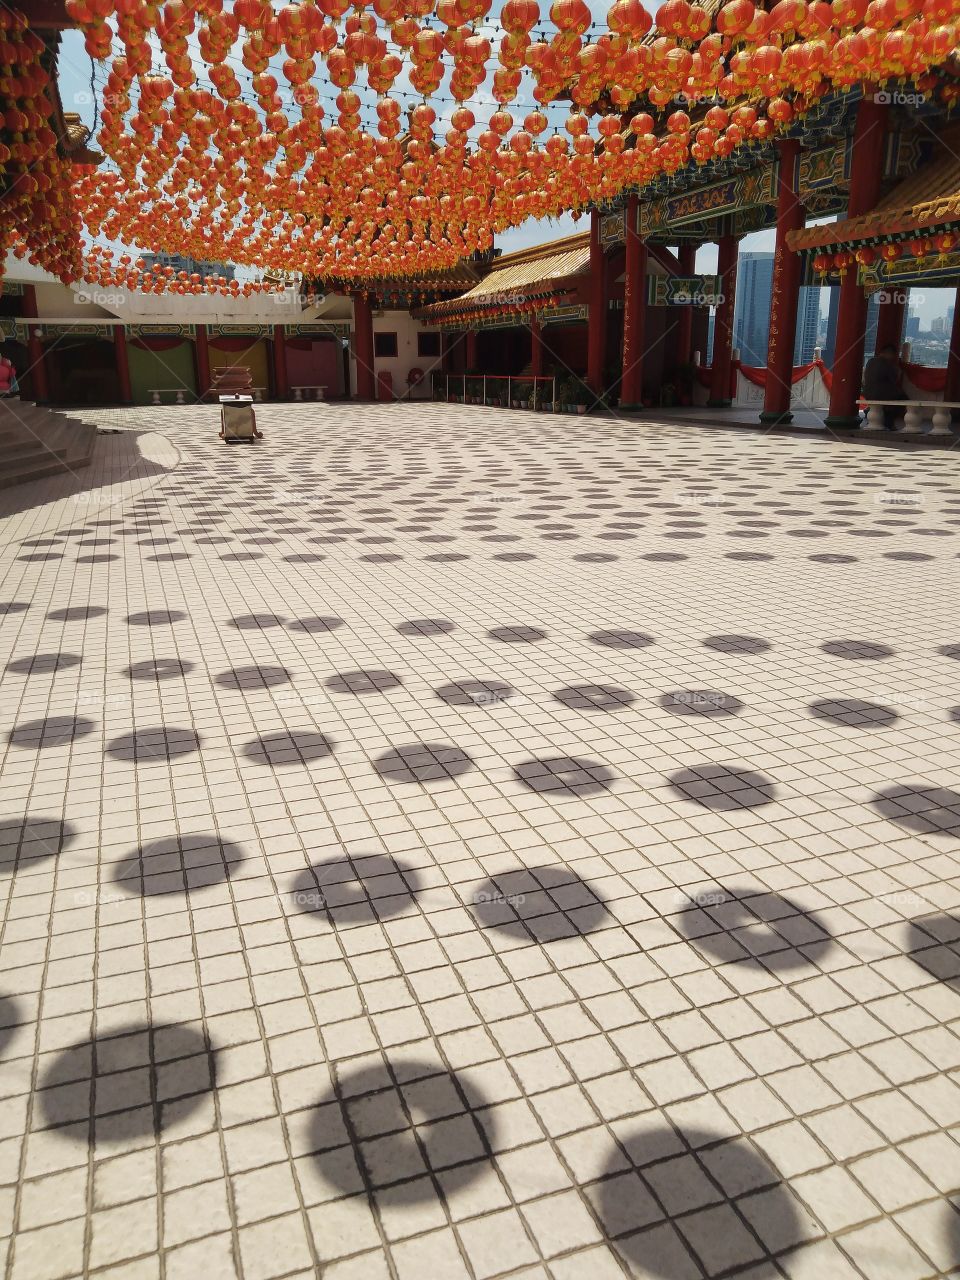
[0,404,960,1280]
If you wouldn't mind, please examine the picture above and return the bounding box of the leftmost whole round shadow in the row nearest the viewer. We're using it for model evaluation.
[36,1023,216,1147]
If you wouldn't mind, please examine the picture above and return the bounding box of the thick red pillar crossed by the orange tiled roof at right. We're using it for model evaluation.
[826,94,887,430]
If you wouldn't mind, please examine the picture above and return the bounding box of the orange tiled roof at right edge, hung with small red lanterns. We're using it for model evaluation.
[787,125,960,251]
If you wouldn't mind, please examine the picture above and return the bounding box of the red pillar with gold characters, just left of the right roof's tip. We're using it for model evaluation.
[760,138,806,422]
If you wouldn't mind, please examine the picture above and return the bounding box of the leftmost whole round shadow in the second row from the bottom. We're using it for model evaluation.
[113,832,246,897]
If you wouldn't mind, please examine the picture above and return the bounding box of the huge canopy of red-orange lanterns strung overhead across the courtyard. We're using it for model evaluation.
[3,0,960,292]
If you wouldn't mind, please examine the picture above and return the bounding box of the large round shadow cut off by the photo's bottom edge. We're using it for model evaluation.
[599,1123,804,1280]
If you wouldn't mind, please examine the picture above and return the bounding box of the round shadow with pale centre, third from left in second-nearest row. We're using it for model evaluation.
[291,854,424,924]
